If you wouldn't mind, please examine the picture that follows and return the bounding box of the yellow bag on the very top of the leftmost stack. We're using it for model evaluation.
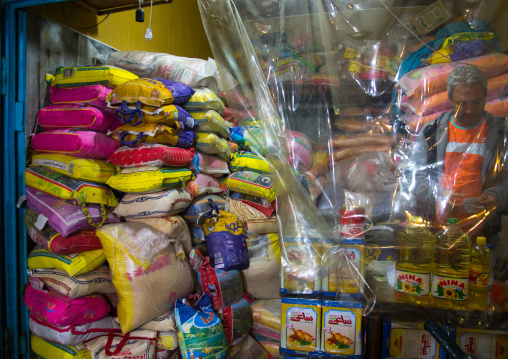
[46,66,139,87]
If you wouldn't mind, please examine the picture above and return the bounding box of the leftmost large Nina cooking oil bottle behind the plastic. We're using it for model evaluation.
[395,216,435,304]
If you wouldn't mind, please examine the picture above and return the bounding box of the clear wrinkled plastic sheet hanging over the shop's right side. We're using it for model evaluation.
[198,0,508,338]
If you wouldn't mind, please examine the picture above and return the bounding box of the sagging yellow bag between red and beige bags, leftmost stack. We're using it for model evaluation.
[28,248,106,277]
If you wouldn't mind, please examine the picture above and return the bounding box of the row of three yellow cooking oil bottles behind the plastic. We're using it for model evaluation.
[395,217,494,310]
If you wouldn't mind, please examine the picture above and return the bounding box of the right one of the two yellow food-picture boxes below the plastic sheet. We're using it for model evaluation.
[321,301,364,356]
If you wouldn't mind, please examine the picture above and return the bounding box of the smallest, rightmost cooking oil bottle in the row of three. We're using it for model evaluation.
[468,237,491,310]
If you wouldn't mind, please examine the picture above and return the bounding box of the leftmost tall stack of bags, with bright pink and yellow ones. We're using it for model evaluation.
[24,67,137,358]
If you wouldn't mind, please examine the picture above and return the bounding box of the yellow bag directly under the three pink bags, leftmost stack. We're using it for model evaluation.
[32,153,120,183]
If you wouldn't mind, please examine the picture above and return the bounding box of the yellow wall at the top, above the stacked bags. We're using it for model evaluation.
[30,0,213,59]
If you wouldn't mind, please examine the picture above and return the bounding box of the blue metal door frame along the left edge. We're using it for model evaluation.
[0,0,66,358]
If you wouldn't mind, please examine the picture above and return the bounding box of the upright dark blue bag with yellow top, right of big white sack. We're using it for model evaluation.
[203,200,249,270]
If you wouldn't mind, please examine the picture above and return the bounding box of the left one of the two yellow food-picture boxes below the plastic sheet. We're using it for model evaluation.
[280,298,321,355]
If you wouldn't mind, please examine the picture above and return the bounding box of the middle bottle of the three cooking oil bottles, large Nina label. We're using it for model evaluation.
[430,218,471,309]
